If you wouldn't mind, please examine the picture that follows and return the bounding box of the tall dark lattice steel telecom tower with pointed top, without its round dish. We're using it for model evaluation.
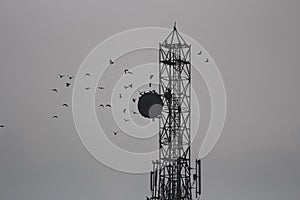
[147,24,201,200]
